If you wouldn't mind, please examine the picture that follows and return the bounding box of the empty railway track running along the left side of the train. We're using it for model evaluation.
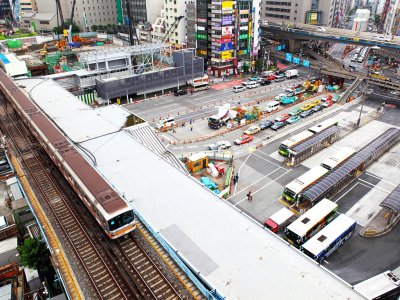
[0,99,134,300]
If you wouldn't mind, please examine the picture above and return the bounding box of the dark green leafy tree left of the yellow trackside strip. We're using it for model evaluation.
[18,238,51,274]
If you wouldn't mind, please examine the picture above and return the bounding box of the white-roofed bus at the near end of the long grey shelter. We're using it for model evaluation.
[282,166,328,204]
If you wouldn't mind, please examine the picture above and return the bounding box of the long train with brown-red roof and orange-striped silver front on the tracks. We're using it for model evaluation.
[0,70,135,239]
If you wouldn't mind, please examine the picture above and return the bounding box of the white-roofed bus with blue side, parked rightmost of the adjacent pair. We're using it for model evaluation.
[301,214,357,263]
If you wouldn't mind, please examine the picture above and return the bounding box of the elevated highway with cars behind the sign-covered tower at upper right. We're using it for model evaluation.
[261,21,400,52]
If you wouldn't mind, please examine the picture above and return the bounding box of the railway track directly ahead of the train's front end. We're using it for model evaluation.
[117,235,183,300]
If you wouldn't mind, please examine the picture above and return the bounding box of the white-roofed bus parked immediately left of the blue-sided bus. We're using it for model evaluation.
[285,198,338,248]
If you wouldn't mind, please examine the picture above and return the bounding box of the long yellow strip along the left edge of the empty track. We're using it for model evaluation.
[10,155,84,299]
